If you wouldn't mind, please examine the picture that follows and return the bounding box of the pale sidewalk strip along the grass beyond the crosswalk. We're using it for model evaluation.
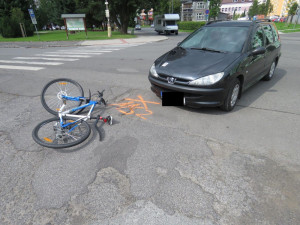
[0,35,168,48]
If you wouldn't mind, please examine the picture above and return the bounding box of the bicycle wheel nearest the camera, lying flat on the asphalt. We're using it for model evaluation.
[32,117,91,148]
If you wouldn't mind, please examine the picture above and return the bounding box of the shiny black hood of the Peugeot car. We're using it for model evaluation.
[156,47,241,80]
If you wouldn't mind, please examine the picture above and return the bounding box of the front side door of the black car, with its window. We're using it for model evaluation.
[245,25,265,89]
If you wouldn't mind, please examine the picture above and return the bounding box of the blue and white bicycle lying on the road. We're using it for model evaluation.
[32,78,113,148]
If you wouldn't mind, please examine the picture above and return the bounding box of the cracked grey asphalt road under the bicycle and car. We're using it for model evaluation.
[0,28,300,225]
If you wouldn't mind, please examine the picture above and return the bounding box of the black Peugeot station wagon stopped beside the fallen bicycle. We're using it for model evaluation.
[148,21,281,111]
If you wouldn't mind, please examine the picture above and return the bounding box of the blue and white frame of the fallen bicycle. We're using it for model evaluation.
[58,95,98,132]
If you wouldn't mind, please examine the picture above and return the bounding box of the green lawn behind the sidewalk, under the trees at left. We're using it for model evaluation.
[0,30,136,42]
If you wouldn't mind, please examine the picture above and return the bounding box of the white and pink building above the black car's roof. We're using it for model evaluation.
[220,0,253,15]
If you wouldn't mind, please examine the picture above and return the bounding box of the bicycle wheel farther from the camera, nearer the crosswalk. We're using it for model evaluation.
[41,78,84,116]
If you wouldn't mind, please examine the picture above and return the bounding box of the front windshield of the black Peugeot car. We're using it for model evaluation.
[180,27,249,52]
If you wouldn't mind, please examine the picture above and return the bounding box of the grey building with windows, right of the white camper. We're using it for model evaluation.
[181,0,208,21]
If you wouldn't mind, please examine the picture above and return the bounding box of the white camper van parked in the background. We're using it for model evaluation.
[154,14,180,35]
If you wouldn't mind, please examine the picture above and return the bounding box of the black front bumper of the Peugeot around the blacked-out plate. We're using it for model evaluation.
[148,75,227,108]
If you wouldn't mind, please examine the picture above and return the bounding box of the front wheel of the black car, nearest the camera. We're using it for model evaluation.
[221,78,241,112]
